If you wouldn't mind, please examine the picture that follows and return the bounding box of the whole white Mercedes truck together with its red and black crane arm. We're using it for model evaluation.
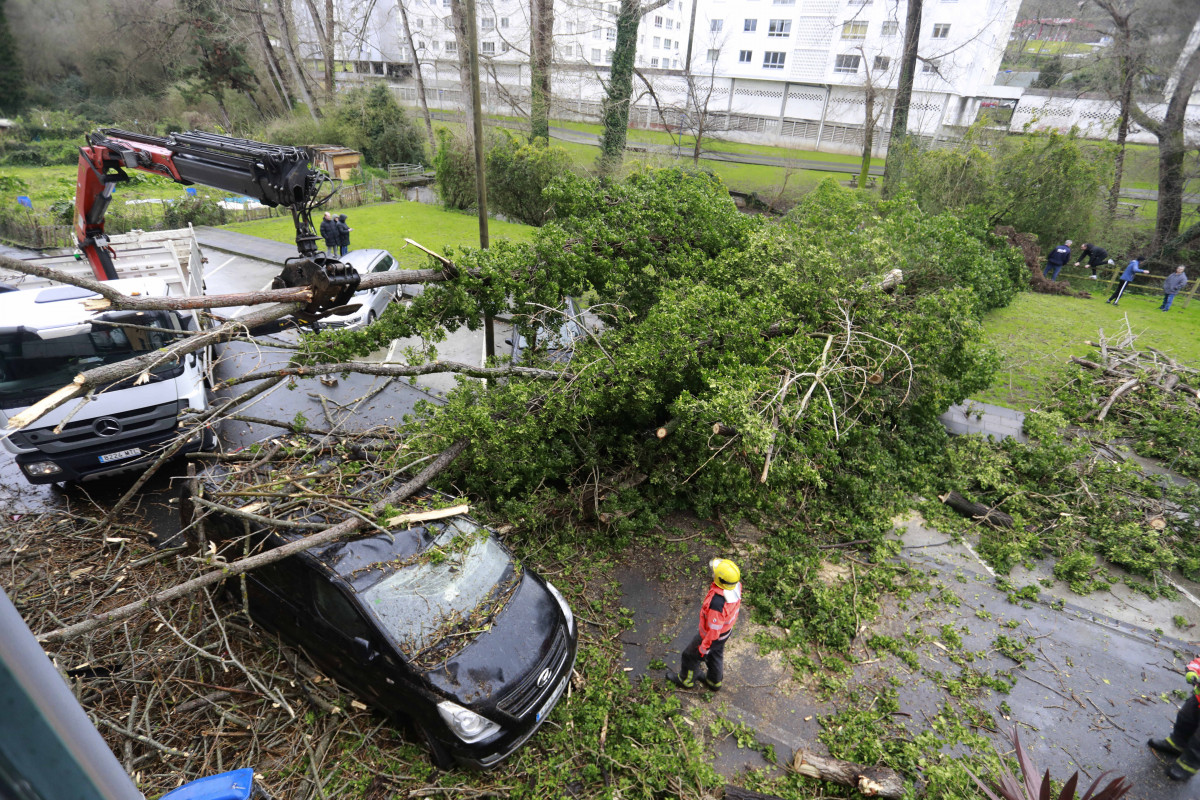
[0,128,359,483]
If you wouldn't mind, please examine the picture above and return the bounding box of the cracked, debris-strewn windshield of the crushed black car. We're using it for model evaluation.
[359,519,517,666]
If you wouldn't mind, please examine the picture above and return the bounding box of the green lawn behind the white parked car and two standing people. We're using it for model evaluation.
[224,201,533,270]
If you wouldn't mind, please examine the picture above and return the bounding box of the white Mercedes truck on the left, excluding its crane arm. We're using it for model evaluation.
[0,228,215,483]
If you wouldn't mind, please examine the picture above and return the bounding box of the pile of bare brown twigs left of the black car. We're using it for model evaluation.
[0,513,426,798]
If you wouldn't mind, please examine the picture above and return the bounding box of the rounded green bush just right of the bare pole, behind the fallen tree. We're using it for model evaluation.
[487,130,571,225]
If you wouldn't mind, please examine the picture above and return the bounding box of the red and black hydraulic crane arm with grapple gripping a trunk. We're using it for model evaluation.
[74,128,359,315]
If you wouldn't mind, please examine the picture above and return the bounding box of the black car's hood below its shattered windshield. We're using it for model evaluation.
[427,572,564,705]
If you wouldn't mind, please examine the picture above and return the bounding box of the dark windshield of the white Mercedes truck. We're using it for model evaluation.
[0,311,181,408]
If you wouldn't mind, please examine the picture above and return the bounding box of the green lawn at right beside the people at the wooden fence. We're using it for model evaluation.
[973,287,1200,410]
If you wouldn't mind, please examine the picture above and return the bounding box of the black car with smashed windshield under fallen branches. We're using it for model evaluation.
[184,470,577,769]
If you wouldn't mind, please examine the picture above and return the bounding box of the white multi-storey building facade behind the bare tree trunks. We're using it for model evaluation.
[293,0,1020,152]
